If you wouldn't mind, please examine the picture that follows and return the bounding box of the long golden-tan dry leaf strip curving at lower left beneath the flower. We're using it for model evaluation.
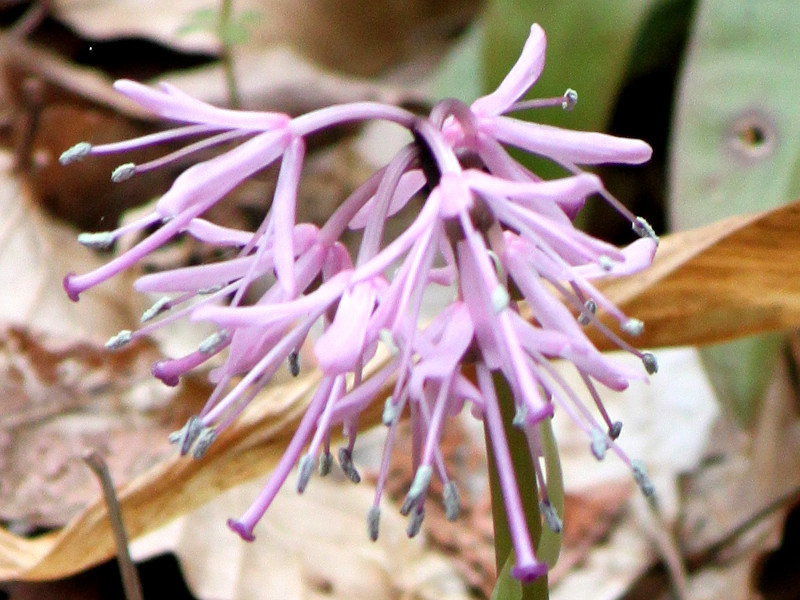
[0,374,380,580]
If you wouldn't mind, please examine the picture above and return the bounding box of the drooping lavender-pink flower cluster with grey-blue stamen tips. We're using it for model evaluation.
[62,25,657,581]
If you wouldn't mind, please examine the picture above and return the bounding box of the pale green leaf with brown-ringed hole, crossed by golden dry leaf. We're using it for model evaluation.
[670,0,800,425]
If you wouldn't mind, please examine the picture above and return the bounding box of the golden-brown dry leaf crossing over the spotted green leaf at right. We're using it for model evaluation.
[593,202,800,349]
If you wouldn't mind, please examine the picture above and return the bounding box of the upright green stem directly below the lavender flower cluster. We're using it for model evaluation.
[484,373,549,600]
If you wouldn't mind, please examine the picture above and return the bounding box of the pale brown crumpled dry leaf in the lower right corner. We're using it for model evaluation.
[680,356,800,575]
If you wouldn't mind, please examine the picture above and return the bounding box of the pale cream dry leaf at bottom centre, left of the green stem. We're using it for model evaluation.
[132,475,470,600]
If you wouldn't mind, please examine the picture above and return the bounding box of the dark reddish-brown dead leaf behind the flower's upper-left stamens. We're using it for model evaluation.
[0,35,206,230]
